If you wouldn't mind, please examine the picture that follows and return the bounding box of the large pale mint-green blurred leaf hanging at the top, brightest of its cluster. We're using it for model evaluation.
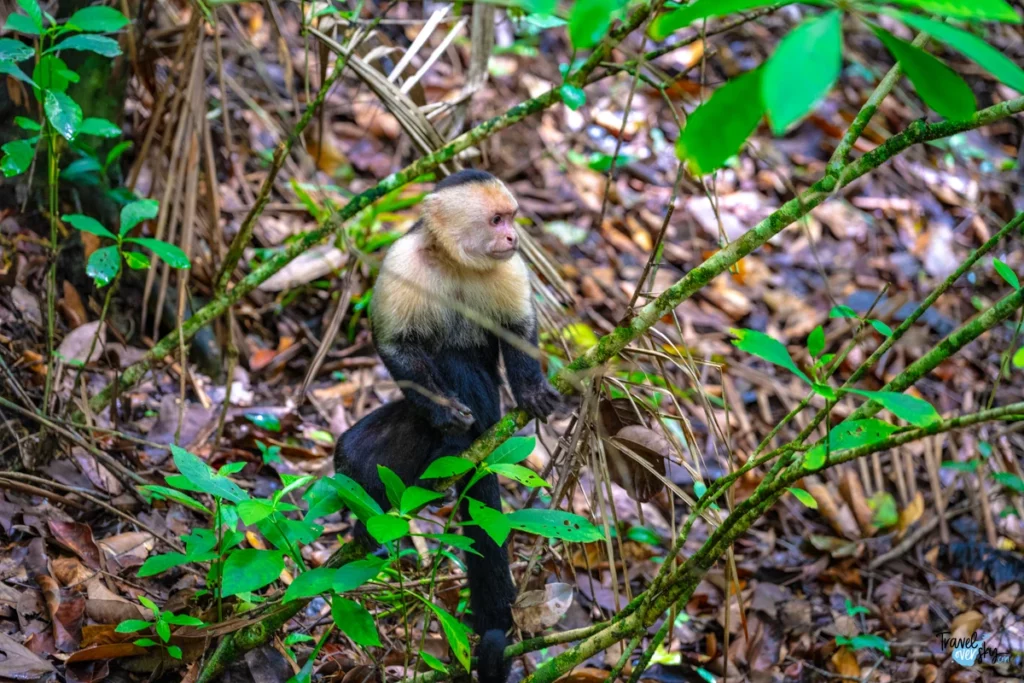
[761,9,843,135]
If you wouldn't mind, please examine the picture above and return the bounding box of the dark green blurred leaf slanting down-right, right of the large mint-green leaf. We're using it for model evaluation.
[871,26,977,121]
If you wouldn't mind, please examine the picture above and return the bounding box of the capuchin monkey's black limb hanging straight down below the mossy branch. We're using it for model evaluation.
[462,474,516,683]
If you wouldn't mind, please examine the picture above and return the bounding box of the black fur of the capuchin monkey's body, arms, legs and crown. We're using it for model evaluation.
[335,171,558,683]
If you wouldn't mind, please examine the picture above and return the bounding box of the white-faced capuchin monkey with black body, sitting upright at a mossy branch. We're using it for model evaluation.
[335,170,561,683]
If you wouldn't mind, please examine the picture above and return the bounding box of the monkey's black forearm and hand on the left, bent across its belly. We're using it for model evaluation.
[377,338,474,431]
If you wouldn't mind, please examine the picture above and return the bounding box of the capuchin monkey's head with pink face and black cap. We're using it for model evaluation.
[423,170,519,270]
